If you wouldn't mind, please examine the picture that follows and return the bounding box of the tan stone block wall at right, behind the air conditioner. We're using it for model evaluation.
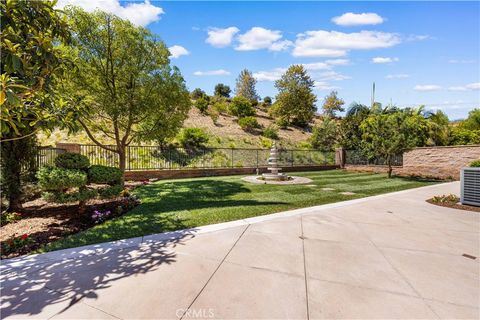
[345,145,480,180]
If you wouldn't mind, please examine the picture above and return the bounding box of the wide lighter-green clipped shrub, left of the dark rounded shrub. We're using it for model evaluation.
[37,167,87,191]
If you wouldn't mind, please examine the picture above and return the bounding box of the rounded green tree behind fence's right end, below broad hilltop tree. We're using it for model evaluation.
[309,117,339,151]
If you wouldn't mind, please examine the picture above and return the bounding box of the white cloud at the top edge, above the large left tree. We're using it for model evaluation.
[57,0,165,26]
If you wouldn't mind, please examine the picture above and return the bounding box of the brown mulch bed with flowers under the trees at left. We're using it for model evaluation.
[0,183,145,259]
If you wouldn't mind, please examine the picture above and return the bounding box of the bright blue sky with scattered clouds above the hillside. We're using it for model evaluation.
[60,0,480,119]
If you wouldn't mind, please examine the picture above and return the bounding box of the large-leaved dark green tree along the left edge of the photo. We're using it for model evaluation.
[0,0,75,210]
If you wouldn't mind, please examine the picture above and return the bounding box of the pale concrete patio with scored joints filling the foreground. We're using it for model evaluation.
[1,182,480,319]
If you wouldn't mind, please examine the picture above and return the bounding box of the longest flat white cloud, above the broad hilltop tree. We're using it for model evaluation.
[293,30,401,57]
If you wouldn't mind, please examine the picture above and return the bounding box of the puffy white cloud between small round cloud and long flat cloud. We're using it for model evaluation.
[235,27,292,51]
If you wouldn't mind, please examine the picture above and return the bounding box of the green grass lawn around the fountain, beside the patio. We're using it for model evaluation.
[44,170,433,251]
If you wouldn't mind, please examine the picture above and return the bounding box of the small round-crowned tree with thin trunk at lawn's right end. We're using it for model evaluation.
[360,111,429,178]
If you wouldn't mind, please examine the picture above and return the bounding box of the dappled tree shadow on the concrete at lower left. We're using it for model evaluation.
[0,218,195,318]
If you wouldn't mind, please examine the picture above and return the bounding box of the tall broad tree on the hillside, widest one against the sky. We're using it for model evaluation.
[270,64,317,126]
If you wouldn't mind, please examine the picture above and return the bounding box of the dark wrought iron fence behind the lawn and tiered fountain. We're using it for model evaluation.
[80,145,335,170]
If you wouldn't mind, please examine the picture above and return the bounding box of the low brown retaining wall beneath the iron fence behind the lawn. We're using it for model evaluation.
[125,165,339,181]
